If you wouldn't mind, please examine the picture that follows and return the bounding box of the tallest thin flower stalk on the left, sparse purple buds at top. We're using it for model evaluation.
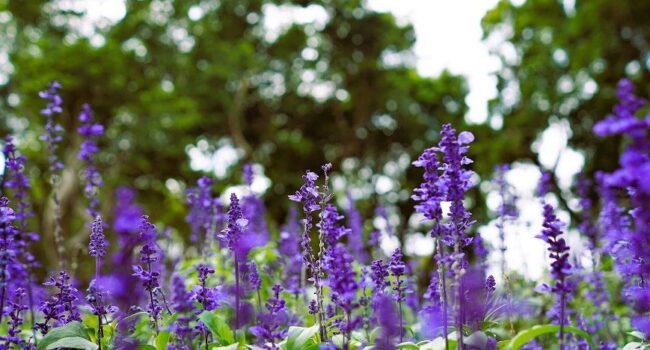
[38,81,66,268]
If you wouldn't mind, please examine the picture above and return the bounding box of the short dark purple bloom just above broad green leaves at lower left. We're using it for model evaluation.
[35,271,81,335]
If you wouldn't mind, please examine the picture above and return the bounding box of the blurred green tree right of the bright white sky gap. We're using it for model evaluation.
[483,0,650,183]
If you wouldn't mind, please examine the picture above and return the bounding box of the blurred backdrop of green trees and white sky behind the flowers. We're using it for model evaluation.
[0,0,650,284]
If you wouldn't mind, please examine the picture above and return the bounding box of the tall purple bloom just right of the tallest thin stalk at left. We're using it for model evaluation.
[77,104,104,219]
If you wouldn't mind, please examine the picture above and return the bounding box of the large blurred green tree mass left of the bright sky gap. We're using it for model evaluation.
[0,0,468,274]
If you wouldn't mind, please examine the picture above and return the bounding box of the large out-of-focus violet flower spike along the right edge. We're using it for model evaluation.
[594,79,650,337]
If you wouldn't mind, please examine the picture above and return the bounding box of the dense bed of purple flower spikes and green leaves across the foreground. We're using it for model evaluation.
[0,80,650,350]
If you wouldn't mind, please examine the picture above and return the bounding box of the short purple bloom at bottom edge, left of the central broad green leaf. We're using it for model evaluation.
[250,284,287,350]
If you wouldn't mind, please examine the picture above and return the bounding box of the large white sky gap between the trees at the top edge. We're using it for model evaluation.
[367,0,499,122]
